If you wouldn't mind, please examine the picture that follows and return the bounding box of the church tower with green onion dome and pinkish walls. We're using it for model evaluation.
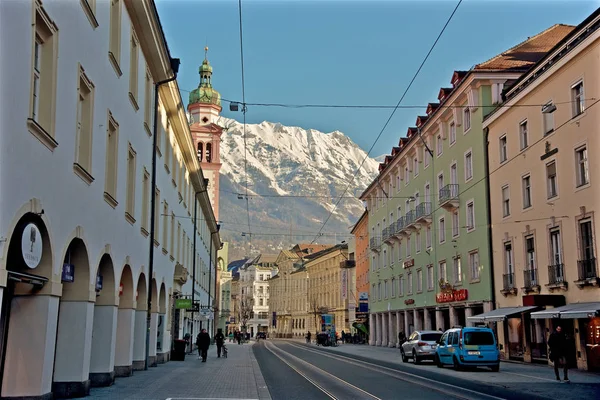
[188,47,223,221]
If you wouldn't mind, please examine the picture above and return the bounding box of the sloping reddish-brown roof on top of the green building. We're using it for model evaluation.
[473,24,575,72]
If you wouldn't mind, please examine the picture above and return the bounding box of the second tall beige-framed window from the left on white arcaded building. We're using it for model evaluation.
[75,65,94,181]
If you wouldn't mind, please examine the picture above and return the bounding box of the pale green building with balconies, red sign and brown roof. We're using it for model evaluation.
[361,29,568,347]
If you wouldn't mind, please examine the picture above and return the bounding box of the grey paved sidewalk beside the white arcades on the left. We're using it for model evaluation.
[88,343,271,400]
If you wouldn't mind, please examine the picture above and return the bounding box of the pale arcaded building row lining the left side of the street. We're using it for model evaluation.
[0,0,221,399]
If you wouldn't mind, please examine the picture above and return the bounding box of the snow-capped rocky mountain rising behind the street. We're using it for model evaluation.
[214,118,378,258]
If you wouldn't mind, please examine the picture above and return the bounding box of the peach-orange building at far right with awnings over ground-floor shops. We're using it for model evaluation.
[478,10,600,369]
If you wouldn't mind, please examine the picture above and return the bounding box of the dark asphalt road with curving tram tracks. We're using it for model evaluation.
[253,340,599,400]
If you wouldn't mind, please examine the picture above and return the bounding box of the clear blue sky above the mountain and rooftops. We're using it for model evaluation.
[156,0,600,157]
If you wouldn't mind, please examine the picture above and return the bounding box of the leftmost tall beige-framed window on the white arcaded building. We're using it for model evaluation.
[27,1,58,150]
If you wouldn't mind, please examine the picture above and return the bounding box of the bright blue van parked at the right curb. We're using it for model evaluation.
[435,327,500,372]
